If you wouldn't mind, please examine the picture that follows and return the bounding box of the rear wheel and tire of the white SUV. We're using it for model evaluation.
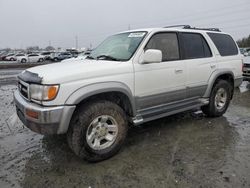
[201,80,233,117]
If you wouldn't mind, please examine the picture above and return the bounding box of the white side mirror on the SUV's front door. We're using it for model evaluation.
[142,49,162,64]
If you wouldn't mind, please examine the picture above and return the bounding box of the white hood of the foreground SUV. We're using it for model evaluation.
[22,59,133,84]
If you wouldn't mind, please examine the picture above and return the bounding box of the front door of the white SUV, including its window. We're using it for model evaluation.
[134,32,186,110]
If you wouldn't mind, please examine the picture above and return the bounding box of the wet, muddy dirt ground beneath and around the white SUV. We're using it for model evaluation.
[0,78,250,188]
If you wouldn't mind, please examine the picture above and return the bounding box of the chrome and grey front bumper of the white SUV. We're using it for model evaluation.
[14,91,75,135]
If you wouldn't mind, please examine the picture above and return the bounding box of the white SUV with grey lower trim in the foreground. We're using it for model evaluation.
[14,26,243,161]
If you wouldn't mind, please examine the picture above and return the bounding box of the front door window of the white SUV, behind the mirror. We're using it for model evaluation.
[145,33,180,61]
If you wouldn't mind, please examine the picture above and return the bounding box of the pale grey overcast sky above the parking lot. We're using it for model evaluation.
[0,0,250,48]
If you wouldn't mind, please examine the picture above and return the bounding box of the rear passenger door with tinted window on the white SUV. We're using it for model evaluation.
[180,32,217,98]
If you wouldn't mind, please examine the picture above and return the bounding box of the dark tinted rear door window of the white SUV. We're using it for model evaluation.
[182,33,212,59]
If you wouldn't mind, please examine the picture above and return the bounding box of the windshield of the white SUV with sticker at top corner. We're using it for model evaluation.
[88,31,146,61]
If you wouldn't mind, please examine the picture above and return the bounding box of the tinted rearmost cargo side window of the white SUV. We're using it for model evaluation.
[208,33,238,56]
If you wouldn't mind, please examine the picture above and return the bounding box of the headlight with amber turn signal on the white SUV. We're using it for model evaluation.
[30,84,59,101]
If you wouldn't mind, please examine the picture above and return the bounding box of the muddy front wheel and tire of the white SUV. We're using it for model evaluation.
[67,100,128,162]
